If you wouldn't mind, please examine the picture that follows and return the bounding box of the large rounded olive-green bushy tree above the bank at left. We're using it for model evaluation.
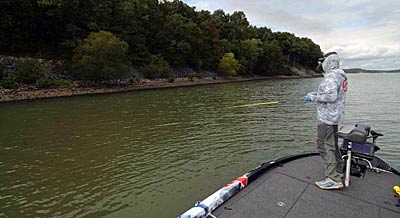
[72,31,130,81]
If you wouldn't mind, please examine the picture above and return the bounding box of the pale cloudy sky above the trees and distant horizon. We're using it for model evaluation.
[184,0,400,70]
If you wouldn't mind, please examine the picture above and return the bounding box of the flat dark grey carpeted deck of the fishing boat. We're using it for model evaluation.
[213,156,400,218]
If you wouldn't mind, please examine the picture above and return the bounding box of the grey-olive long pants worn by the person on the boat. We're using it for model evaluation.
[317,123,343,182]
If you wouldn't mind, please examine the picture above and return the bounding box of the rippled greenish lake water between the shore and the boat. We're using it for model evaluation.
[0,74,400,218]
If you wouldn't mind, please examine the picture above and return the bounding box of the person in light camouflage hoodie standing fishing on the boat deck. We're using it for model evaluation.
[304,52,348,189]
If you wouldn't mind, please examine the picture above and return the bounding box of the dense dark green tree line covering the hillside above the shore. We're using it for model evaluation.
[0,0,322,80]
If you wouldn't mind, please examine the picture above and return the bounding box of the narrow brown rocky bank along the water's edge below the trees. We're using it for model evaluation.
[0,74,320,103]
